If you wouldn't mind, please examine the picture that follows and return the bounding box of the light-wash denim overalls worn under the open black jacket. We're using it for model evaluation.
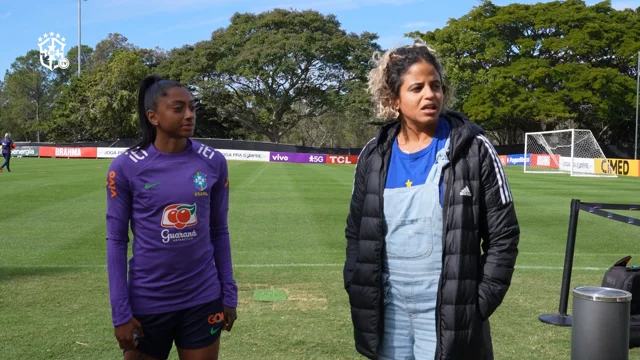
[380,140,449,360]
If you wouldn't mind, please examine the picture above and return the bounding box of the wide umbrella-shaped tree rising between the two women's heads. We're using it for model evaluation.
[179,9,379,142]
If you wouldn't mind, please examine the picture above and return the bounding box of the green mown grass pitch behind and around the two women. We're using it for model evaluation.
[0,158,640,360]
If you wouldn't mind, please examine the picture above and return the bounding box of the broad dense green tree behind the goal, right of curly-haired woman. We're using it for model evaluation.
[408,0,640,145]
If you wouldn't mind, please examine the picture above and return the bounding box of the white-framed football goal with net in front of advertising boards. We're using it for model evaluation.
[524,129,617,177]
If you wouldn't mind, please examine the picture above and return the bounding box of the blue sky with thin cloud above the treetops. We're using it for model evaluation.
[0,0,640,79]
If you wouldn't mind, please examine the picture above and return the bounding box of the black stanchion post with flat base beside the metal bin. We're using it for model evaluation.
[538,199,580,326]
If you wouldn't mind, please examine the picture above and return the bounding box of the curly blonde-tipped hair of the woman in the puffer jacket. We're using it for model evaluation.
[368,39,453,120]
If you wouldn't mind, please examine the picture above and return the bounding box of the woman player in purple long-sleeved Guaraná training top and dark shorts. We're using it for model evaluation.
[106,76,238,360]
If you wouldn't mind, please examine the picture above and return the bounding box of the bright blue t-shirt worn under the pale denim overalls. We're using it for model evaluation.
[385,118,451,198]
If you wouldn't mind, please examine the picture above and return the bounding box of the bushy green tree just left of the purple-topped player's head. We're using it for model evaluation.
[46,33,182,142]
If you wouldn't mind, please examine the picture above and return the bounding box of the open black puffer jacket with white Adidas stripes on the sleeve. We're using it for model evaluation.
[344,111,520,360]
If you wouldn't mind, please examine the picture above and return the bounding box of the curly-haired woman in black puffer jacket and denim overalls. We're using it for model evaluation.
[344,39,520,360]
